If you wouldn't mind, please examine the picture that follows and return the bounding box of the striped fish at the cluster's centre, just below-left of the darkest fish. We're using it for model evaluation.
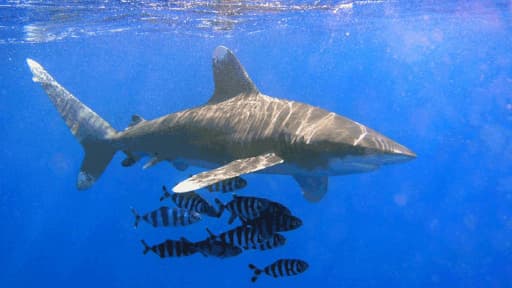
[206,226,270,250]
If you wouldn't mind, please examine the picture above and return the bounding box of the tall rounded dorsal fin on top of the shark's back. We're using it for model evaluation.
[208,46,258,104]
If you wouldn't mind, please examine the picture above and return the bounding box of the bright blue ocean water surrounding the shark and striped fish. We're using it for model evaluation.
[0,1,512,288]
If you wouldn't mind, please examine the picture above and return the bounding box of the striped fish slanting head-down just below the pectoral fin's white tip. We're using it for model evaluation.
[160,186,220,218]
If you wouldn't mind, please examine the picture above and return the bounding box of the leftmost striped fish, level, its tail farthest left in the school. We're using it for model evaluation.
[132,206,201,228]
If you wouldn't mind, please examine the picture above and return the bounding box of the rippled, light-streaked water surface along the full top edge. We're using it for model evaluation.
[0,0,512,44]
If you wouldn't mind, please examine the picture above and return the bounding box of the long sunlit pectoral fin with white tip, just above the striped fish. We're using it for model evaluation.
[172,153,284,193]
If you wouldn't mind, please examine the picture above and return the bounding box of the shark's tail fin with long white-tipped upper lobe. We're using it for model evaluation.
[27,59,117,190]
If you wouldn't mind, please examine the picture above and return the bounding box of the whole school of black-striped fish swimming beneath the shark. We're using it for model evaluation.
[131,177,309,282]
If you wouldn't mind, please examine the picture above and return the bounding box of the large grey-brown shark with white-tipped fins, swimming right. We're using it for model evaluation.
[27,46,416,202]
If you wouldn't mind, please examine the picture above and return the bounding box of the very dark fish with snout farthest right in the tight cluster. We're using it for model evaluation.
[246,213,302,239]
